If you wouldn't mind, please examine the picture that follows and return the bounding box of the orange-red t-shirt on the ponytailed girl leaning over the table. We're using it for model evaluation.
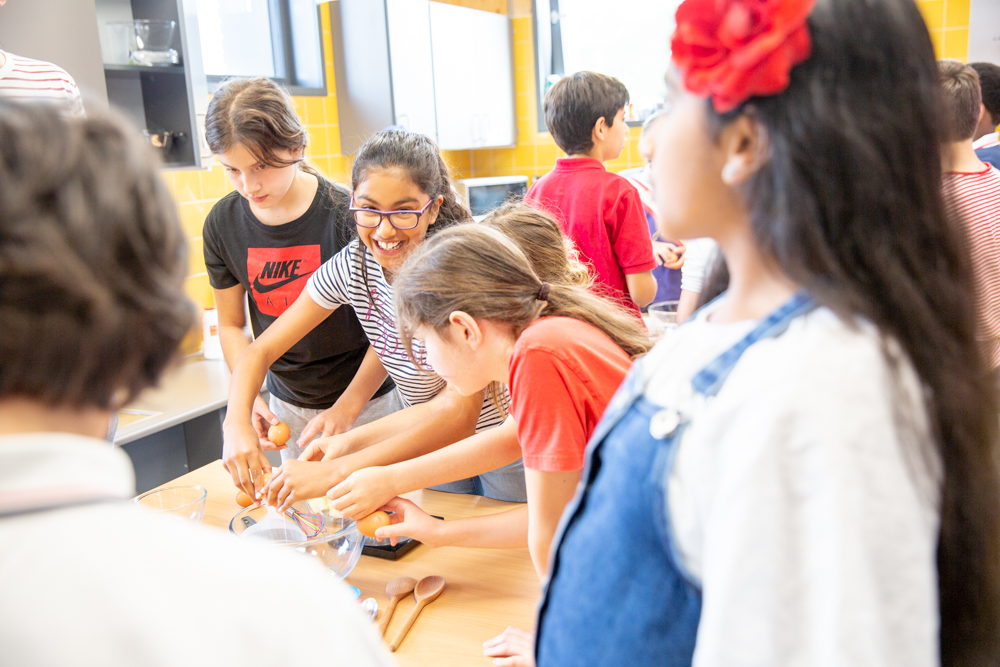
[510,317,632,472]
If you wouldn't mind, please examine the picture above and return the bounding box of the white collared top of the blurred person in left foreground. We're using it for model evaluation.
[0,433,393,667]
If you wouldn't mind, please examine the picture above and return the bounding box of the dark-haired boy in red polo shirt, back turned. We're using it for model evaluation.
[525,72,656,316]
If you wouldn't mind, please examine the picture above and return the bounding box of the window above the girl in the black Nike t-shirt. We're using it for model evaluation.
[197,0,326,95]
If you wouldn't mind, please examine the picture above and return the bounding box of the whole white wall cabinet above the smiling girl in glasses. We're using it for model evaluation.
[330,0,517,153]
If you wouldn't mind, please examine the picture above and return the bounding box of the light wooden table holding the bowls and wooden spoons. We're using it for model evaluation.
[165,461,539,667]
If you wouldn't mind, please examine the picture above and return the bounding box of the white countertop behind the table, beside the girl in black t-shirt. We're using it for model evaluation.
[115,354,230,445]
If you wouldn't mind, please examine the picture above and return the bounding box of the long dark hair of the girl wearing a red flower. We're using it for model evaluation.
[706,0,1000,667]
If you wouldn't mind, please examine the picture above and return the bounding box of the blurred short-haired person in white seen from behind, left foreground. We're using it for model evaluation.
[0,101,392,667]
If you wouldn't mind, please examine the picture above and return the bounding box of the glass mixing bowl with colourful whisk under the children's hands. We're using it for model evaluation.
[229,503,365,579]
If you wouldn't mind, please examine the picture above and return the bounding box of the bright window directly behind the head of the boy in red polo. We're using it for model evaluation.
[535,0,680,130]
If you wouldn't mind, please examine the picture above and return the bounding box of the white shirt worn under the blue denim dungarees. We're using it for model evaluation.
[642,308,940,667]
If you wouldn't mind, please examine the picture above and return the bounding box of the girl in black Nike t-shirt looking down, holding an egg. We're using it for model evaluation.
[202,78,401,459]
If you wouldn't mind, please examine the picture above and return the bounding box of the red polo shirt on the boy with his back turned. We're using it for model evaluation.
[524,157,656,315]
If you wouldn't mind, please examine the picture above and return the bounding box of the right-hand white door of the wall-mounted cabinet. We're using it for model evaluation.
[430,2,515,149]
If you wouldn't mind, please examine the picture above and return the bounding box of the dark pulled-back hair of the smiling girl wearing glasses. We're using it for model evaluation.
[351,127,472,316]
